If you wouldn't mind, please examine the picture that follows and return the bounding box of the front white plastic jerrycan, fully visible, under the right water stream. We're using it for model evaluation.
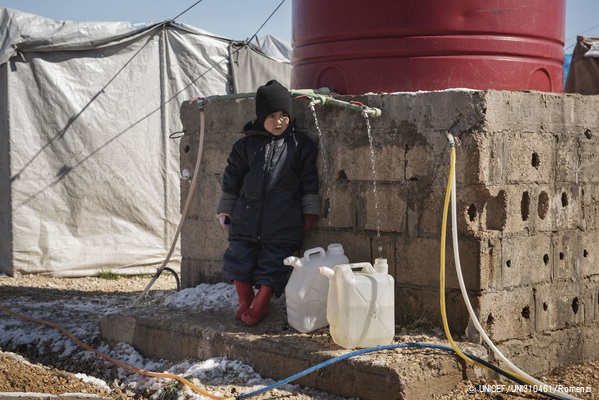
[320,258,395,349]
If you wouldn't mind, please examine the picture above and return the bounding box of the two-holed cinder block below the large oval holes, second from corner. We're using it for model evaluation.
[501,234,554,289]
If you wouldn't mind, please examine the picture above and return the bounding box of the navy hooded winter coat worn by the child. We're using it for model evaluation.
[217,124,320,246]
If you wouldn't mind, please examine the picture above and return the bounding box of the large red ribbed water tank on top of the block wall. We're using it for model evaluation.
[291,0,565,94]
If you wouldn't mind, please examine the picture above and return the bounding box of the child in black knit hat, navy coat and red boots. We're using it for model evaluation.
[217,80,320,325]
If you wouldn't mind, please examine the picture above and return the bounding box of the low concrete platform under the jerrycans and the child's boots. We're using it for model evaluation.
[100,299,485,400]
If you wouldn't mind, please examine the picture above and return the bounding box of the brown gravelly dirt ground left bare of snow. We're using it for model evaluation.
[0,276,599,400]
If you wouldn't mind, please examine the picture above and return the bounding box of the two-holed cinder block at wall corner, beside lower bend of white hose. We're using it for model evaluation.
[475,287,535,342]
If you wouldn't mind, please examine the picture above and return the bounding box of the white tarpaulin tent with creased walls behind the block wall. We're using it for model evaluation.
[0,8,291,276]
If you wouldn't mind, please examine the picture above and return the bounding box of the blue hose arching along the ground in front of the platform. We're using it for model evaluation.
[235,342,564,399]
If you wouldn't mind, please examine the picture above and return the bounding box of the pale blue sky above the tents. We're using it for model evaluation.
[0,0,599,53]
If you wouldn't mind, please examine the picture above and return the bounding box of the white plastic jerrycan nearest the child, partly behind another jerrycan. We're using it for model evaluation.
[283,243,349,333]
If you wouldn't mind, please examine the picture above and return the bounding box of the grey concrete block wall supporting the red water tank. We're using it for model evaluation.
[181,90,599,373]
